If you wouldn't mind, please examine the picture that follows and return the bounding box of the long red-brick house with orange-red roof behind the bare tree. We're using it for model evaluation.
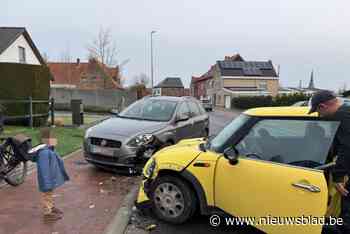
[47,58,122,90]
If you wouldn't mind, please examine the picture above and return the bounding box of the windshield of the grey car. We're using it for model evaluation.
[119,99,177,121]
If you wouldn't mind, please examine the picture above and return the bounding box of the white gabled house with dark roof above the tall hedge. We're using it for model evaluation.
[0,27,45,65]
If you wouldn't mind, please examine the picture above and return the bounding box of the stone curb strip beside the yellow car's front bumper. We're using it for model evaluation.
[103,184,139,234]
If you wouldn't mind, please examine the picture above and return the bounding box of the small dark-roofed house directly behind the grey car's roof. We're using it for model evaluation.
[153,77,185,97]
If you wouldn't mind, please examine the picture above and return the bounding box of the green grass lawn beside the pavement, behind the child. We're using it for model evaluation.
[0,126,85,156]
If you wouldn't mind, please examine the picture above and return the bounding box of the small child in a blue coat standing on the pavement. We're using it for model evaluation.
[34,128,69,222]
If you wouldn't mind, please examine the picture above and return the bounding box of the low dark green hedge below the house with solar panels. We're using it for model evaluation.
[232,93,310,109]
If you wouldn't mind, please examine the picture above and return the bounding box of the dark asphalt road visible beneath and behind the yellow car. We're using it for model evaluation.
[126,110,260,234]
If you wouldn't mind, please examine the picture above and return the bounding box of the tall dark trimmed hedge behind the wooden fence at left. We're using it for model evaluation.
[0,63,51,125]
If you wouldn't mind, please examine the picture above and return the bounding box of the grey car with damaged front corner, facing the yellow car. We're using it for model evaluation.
[84,96,209,171]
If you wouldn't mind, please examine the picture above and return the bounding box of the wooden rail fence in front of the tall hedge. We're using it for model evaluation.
[0,97,55,128]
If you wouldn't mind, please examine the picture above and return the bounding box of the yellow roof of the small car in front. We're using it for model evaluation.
[244,106,318,118]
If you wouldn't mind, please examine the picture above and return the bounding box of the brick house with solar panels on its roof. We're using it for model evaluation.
[207,55,279,108]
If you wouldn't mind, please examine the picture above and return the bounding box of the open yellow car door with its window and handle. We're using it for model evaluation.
[214,119,339,234]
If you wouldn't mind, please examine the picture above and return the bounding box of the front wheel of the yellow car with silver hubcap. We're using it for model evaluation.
[151,176,196,224]
